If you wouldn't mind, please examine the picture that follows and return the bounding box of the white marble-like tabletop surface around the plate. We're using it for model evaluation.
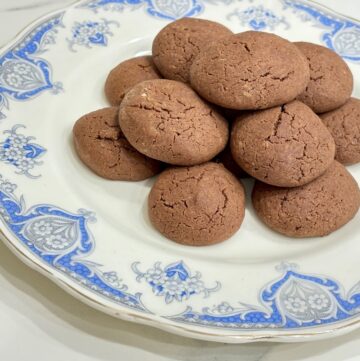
[0,0,360,361]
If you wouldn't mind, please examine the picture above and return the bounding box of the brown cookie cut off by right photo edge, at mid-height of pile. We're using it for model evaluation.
[320,98,360,164]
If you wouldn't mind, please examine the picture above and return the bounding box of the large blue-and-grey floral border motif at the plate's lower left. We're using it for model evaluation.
[0,176,147,312]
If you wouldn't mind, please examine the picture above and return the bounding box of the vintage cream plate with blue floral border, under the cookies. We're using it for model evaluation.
[0,0,360,343]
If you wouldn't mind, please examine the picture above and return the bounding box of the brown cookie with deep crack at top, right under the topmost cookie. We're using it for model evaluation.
[230,100,335,187]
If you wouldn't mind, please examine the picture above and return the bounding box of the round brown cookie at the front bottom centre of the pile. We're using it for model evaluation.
[148,162,245,246]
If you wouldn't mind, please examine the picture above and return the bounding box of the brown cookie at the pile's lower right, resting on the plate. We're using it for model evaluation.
[252,161,360,237]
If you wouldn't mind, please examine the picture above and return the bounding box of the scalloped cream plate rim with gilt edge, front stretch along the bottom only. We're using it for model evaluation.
[0,229,360,343]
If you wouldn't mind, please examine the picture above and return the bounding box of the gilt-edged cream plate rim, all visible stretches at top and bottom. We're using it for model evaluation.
[0,0,360,343]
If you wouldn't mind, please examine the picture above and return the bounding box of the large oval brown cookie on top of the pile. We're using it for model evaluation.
[190,31,310,109]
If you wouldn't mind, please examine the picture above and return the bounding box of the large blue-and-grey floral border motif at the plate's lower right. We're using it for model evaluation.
[170,263,360,329]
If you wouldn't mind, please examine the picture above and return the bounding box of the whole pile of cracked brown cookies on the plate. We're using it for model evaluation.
[73,18,360,246]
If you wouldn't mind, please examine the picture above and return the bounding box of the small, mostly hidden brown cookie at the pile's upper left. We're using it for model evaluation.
[105,56,161,105]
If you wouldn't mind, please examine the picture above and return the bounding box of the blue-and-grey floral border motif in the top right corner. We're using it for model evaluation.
[283,0,360,61]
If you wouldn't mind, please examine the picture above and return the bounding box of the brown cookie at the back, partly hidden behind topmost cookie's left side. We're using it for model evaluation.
[152,18,232,83]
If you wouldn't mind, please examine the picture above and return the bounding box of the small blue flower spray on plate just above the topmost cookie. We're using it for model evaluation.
[227,5,290,30]
